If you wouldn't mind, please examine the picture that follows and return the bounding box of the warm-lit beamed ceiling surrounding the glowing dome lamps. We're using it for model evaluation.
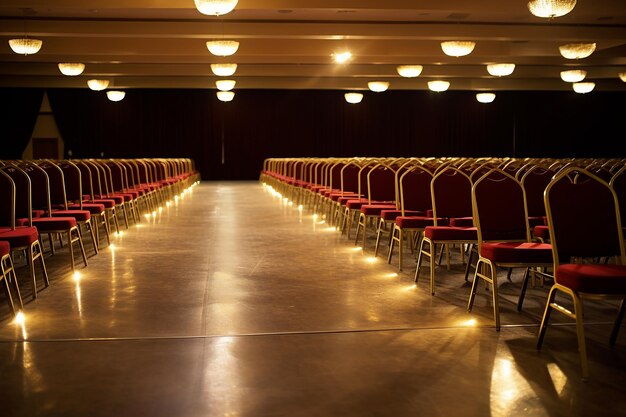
[0,0,626,91]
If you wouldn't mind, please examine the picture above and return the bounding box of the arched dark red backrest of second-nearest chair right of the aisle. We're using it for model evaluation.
[472,169,530,242]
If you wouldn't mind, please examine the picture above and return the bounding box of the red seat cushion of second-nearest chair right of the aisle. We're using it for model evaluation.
[480,242,552,265]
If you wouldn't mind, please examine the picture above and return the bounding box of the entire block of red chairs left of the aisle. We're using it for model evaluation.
[0,158,199,314]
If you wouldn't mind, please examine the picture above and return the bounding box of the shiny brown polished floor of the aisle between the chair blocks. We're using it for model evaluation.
[0,182,626,417]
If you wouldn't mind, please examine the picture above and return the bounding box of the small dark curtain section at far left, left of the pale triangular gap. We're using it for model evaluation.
[0,88,44,159]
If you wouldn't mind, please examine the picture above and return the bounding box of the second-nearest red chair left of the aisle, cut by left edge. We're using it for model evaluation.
[0,166,50,299]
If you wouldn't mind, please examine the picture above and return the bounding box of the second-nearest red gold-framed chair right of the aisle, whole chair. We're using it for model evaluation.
[467,169,552,331]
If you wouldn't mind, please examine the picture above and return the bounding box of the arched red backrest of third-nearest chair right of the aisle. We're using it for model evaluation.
[430,166,472,219]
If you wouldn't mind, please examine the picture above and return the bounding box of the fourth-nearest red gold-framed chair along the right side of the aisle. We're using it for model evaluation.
[381,165,433,271]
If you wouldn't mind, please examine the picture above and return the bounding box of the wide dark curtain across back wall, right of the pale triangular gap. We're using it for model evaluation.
[41,89,626,180]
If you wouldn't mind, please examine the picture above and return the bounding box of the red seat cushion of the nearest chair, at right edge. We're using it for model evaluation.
[555,264,626,294]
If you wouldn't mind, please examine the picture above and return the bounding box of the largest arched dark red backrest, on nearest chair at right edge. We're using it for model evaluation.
[545,166,626,266]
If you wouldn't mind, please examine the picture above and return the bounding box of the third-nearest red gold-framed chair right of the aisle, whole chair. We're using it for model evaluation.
[415,167,478,295]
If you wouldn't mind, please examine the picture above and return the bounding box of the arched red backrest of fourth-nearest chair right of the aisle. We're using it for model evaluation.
[399,165,433,216]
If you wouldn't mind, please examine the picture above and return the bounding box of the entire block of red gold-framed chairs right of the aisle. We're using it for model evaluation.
[261,158,626,377]
